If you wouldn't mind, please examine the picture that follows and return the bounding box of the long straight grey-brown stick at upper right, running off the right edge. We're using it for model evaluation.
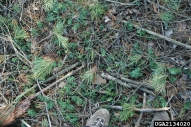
[123,20,191,49]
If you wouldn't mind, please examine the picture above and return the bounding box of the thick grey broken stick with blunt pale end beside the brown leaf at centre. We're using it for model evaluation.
[101,73,155,96]
